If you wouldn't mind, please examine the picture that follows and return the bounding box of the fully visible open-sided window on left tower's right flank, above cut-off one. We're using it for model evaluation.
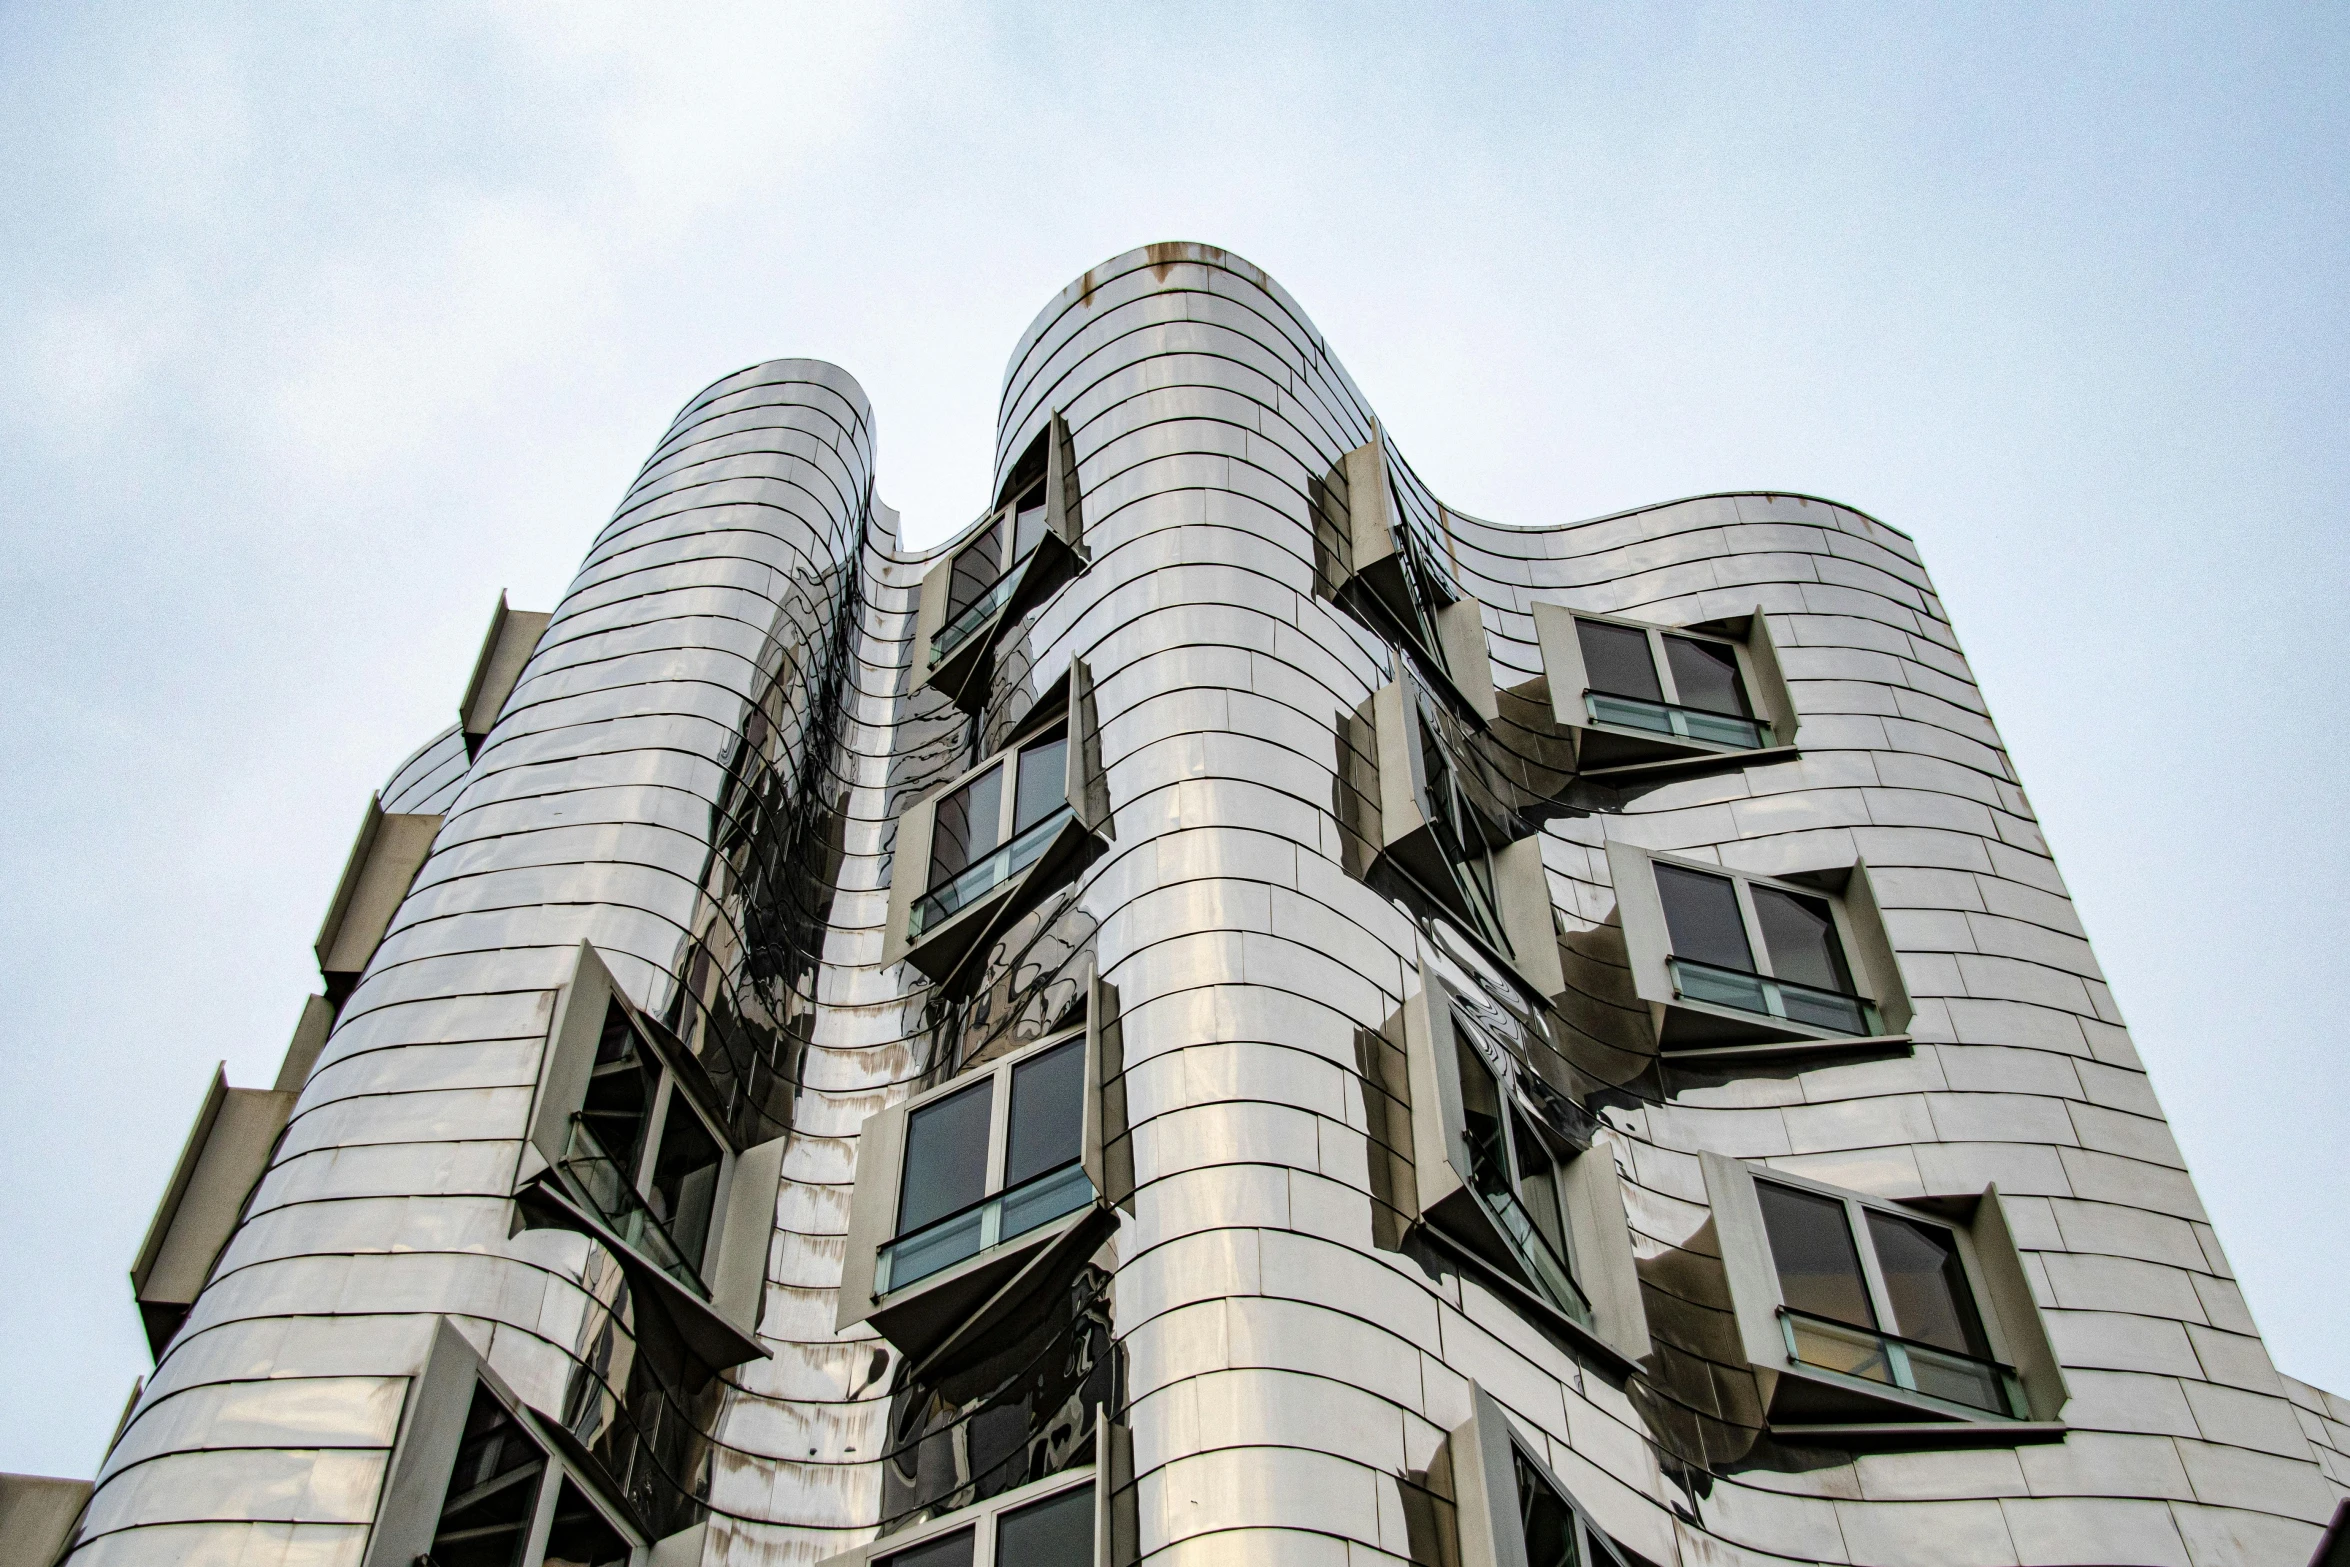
[515,942,785,1367]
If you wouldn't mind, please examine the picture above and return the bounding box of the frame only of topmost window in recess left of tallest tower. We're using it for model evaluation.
[912,409,1090,712]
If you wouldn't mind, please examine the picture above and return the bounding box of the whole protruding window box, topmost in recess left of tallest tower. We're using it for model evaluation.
[914,413,1086,712]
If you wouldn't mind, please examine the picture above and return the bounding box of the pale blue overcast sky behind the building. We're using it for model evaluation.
[0,2,2350,1475]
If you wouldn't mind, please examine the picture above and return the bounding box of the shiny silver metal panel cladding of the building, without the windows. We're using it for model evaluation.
[73,244,2350,1567]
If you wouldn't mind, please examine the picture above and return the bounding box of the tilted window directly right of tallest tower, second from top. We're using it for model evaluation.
[1358,677,1565,996]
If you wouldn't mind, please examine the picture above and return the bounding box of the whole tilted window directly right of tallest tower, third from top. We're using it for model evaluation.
[1372,970,1650,1370]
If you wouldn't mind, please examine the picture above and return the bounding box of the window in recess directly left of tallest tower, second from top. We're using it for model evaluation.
[884,660,1114,980]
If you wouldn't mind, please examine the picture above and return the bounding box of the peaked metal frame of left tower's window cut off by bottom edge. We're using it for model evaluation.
[362,1316,653,1567]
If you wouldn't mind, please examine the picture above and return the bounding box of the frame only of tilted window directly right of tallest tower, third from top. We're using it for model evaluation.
[1387,963,1652,1377]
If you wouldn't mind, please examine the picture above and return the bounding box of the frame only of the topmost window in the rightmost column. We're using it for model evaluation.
[1532,604,1800,782]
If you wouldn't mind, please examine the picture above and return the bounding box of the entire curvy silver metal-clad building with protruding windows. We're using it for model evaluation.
[22,244,2350,1567]
